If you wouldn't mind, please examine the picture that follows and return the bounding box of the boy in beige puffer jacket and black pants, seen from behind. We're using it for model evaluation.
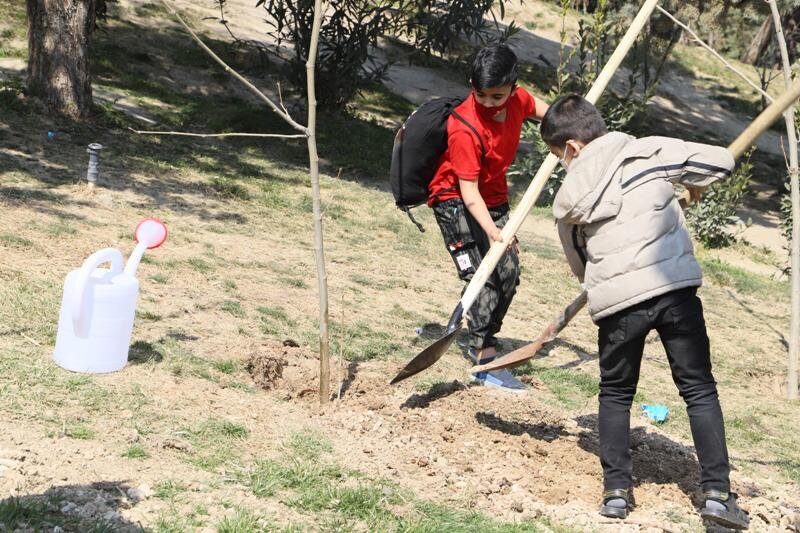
[541,95,749,529]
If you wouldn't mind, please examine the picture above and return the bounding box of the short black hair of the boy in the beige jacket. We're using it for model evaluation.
[539,94,608,148]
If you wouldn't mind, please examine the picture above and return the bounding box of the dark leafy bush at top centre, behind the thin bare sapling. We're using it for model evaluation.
[245,0,506,108]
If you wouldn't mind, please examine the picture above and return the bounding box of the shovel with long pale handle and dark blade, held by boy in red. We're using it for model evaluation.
[389,0,658,384]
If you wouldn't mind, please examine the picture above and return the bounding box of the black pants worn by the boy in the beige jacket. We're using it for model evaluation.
[598,288,730,492]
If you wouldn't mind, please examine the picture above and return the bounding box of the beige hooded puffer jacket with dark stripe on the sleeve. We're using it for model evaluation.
[553,132,734,322]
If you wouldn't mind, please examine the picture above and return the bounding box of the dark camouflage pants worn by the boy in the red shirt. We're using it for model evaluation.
[433,199,519,350]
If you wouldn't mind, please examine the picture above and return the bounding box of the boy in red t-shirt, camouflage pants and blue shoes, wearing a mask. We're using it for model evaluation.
[428,44,547,392]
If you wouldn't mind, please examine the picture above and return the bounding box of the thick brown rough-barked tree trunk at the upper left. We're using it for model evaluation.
[27,0,95,118]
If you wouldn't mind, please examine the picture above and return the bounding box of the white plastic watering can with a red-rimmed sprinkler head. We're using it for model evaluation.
[53,218,167,374]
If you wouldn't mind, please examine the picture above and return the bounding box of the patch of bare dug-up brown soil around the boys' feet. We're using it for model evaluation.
[250,346,800,531]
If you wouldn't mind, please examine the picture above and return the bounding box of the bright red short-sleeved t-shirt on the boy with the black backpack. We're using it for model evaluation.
[428,87,536,207]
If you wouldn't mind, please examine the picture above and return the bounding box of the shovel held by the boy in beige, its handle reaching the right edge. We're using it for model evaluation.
[470,75,800,373]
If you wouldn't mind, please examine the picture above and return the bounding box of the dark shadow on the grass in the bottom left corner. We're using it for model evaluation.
[0,481,145,533]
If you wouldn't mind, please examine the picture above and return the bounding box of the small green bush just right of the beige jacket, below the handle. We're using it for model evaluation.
[686,152,753,248]
